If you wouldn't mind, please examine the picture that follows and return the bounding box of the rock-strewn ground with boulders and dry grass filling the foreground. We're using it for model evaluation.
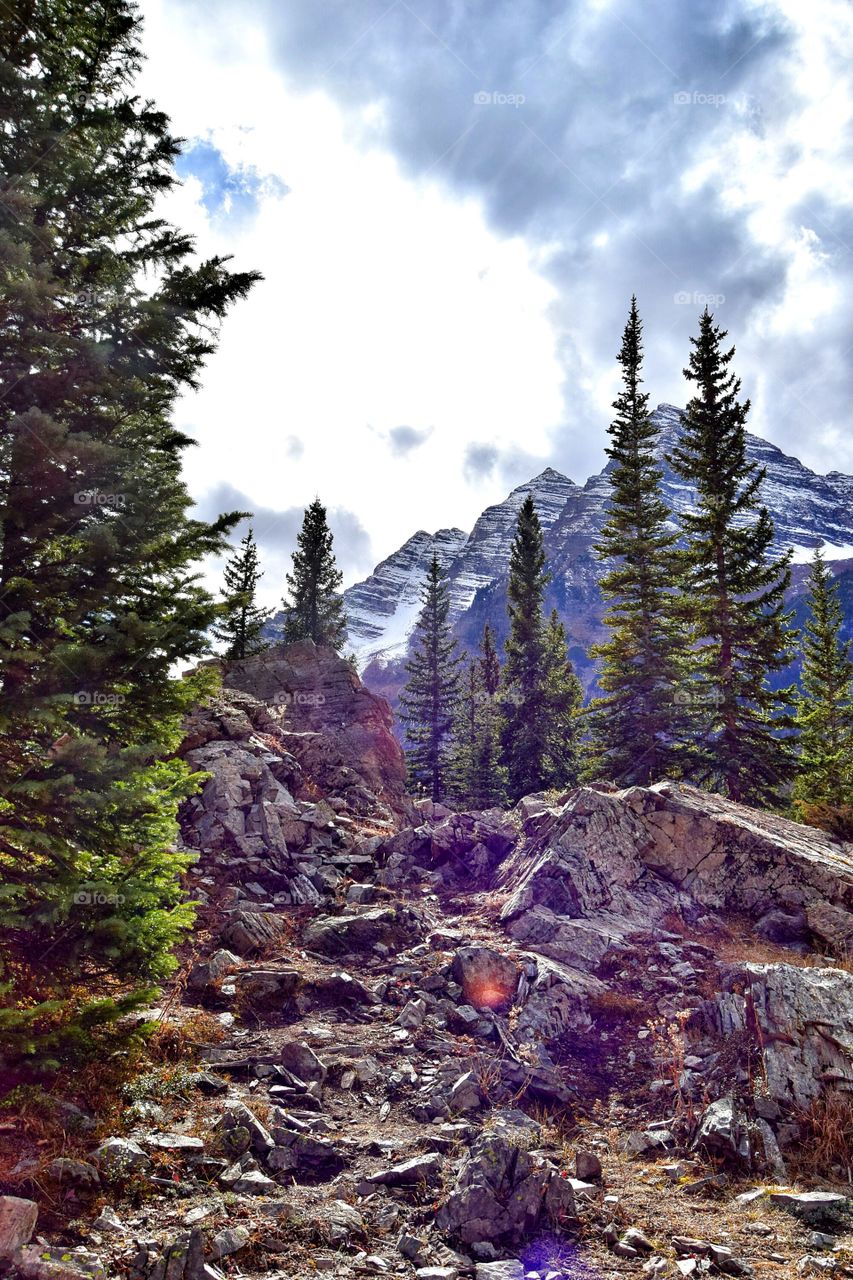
[0,645,853,1280]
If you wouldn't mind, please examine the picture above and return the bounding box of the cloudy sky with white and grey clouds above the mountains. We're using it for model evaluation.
[140,0,853,603]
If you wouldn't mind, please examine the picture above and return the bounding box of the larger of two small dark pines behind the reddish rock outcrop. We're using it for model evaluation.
[284,498,347,650]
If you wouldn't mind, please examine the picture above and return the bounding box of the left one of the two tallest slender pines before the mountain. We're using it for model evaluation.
[587,297,684,786]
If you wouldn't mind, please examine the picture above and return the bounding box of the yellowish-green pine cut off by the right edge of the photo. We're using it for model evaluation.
[794,549,853,840]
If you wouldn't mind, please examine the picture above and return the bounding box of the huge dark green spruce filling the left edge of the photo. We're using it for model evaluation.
[0,0,255,1073]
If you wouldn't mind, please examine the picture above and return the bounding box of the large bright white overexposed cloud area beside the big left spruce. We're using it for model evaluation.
[136,0,562,577]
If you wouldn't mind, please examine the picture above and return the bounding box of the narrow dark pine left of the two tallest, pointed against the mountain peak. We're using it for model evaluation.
[502,494,552,801]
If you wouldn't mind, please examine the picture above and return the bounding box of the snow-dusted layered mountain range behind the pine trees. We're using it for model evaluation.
[345,404,853,695]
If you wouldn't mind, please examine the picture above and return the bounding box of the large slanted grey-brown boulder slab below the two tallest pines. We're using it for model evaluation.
[497,782,853,969]
